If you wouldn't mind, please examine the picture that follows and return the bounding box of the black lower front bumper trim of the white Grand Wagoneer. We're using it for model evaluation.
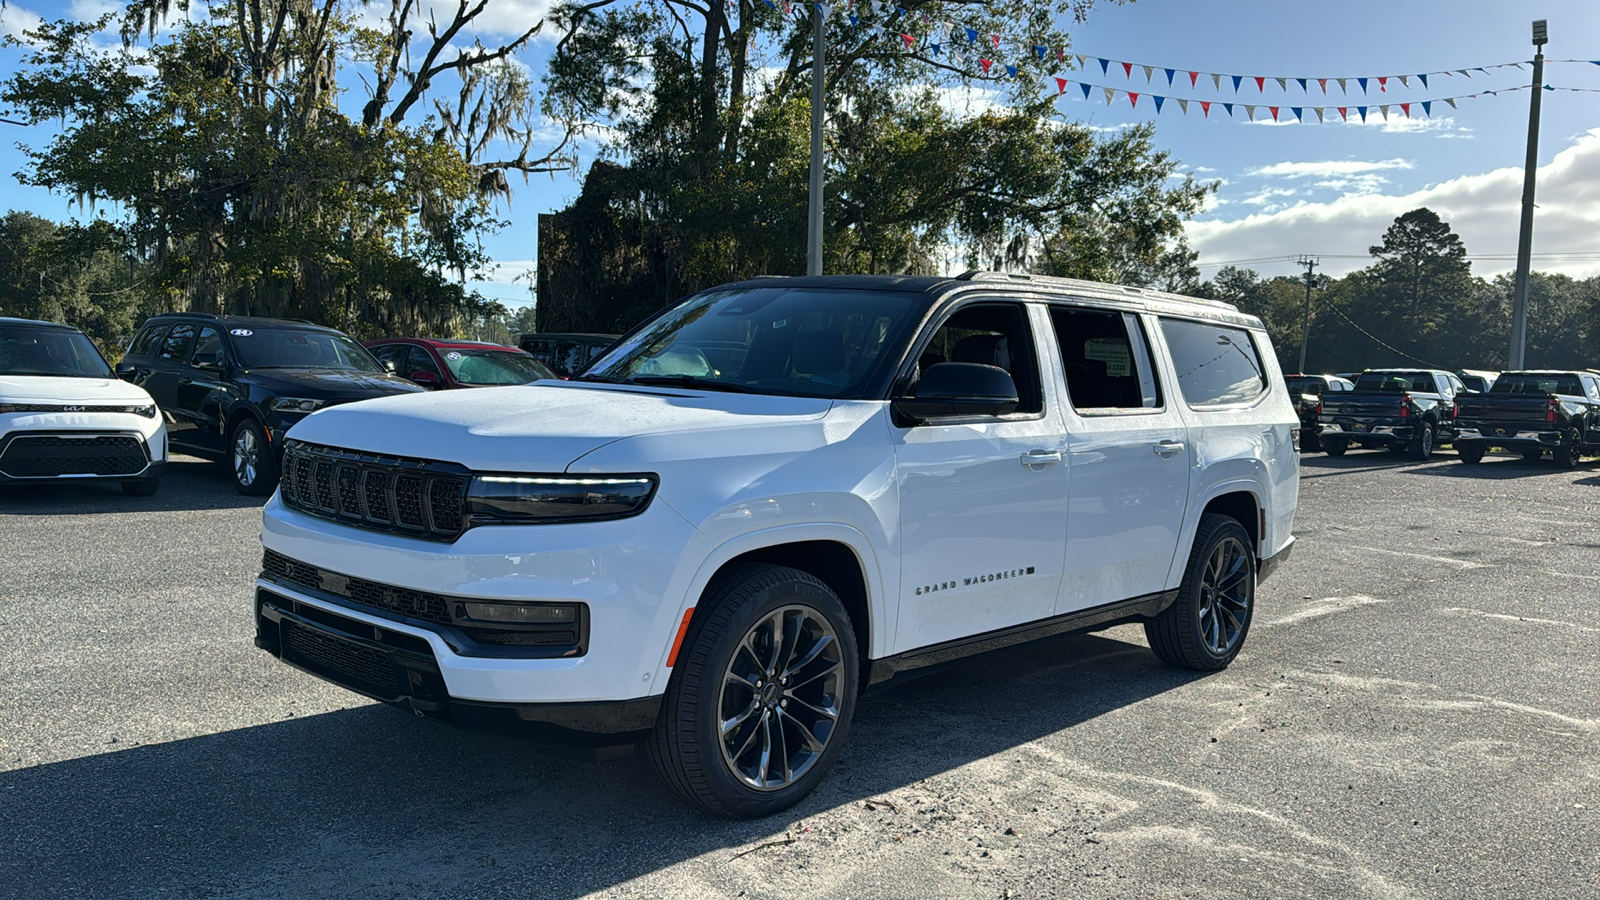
[256,581,661,749]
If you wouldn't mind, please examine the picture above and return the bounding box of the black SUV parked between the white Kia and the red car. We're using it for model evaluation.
[117,312,422,496]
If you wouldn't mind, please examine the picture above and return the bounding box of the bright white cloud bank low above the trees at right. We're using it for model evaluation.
[1187,128,1600,275]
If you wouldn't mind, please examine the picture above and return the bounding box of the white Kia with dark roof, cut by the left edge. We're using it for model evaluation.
[0,317,166,496]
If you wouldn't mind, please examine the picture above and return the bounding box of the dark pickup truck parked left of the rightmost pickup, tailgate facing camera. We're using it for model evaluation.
[1320,368,1466,460]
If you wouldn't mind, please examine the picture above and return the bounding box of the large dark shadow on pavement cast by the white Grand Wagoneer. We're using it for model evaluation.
[0,636,1202,897]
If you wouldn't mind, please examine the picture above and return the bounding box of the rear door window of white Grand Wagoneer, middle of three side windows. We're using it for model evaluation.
[1050,306,1162,410]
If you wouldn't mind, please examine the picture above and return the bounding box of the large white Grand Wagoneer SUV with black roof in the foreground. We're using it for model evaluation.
[256,274,1299,817]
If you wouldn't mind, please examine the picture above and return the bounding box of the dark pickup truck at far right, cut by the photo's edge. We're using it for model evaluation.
[1456,372,1600,469]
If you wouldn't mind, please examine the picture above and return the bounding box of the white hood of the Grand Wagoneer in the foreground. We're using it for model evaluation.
[290,381,832,472]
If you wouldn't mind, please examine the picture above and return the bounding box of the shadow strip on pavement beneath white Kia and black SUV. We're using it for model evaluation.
[0,456,267,516]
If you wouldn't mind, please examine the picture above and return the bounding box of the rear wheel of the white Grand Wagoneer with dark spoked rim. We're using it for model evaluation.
[1144,512,1256,673]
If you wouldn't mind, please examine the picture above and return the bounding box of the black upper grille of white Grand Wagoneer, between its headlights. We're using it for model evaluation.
[280,440,472,541]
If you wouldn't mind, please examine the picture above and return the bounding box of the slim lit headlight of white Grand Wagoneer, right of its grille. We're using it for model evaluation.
[467,476,658,525]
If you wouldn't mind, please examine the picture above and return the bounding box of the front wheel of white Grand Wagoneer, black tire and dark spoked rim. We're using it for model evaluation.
[648,564,861,818]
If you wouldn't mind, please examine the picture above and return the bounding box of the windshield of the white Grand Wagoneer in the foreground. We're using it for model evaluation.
[579,288,925,399]
